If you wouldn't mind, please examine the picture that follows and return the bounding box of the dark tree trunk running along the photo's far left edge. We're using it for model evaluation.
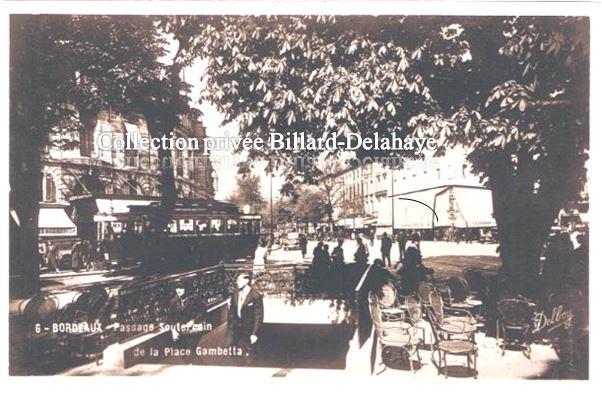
[9,17,50,298]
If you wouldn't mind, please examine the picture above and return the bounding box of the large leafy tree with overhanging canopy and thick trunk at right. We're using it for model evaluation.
[197,16,589,294]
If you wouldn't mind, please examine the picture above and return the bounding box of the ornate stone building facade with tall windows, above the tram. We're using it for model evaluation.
[40,109,215,204]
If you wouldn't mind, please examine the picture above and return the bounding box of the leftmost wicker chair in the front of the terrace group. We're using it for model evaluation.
[368,293,422,373]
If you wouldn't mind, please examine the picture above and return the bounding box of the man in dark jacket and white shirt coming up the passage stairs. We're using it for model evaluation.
[228,273,263,356]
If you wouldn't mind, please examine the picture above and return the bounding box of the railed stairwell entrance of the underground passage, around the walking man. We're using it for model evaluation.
[118,265,366,369]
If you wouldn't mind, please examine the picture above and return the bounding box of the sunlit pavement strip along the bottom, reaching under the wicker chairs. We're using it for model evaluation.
[63,318,561,381]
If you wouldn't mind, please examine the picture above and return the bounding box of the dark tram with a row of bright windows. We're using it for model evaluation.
[115,199,261,271]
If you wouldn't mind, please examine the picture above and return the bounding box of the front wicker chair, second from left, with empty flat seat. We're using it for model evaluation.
[427,309,479,379]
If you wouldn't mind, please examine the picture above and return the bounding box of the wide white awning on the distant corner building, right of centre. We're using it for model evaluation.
[377,185,496,229]
